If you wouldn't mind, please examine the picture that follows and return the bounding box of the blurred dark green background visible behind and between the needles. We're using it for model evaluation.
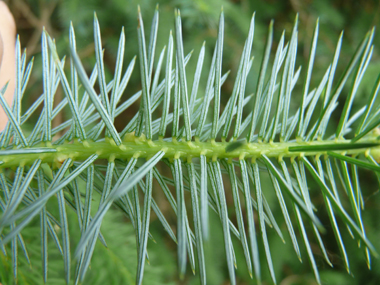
[0,0,380,285]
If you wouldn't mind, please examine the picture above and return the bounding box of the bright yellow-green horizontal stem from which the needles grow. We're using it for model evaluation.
[0,134,380,169]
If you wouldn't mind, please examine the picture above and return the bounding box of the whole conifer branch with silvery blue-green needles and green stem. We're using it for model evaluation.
[0,0,380,283]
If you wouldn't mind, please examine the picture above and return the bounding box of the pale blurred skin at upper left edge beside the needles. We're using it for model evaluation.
[0,1,16,132]
